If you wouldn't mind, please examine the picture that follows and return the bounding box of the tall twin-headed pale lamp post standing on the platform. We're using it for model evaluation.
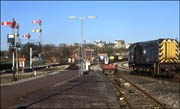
[68,16,96,75]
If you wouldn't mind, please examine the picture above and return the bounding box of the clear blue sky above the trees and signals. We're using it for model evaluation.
[1,1,180,50]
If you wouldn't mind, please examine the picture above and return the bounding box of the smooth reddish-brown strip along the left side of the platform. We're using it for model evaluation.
[0,70,78,108]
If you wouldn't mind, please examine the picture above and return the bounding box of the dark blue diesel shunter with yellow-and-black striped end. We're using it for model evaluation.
[128,39,178,77]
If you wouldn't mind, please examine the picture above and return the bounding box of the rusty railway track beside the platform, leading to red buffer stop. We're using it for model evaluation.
[107,75,166,109]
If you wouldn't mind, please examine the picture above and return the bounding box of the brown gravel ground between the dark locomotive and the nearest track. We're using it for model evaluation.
[121,75,180,108]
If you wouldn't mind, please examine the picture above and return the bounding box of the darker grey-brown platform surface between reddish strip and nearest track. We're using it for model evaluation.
[3,71,120,108]
